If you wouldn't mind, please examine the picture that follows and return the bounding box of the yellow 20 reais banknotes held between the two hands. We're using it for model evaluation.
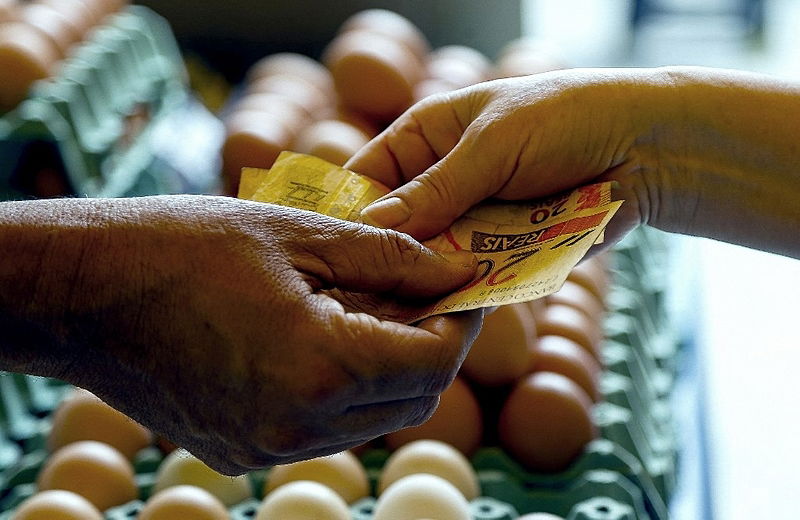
[239,152,622,321]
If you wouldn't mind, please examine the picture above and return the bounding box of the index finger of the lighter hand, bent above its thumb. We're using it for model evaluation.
[344,92,469,189]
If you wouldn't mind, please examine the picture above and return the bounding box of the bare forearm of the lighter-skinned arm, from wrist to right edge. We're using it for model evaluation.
[636,68,800,258]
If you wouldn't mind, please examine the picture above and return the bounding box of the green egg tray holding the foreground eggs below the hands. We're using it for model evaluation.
[0,225,679,520]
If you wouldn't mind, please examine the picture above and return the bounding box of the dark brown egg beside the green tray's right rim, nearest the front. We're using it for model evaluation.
[498,372,597,472]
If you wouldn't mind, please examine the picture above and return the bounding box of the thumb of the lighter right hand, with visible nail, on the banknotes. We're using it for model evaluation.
[361,139,504,240]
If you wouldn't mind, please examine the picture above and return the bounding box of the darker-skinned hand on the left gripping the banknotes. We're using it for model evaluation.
[0,196,482,474]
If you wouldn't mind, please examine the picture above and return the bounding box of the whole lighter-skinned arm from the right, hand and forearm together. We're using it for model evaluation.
[345,67,800,258]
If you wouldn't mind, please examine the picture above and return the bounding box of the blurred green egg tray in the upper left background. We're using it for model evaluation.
[0,6,223,200]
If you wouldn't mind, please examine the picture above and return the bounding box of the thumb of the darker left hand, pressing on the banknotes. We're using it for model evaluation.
[295,226,477,298]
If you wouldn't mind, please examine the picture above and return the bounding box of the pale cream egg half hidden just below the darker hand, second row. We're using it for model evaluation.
[153,448,253,506]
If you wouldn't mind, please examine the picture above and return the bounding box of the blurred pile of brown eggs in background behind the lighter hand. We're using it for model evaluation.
[222,9,562,194]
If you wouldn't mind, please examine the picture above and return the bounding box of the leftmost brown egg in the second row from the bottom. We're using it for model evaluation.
[36,441,139,511]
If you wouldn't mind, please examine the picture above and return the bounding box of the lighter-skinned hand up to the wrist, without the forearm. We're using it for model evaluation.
[345,70,656,248]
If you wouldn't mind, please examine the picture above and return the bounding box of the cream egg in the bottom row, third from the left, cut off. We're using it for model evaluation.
[255,480,350,520]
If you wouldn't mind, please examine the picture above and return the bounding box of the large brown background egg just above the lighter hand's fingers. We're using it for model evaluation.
[323,31,423,121]
